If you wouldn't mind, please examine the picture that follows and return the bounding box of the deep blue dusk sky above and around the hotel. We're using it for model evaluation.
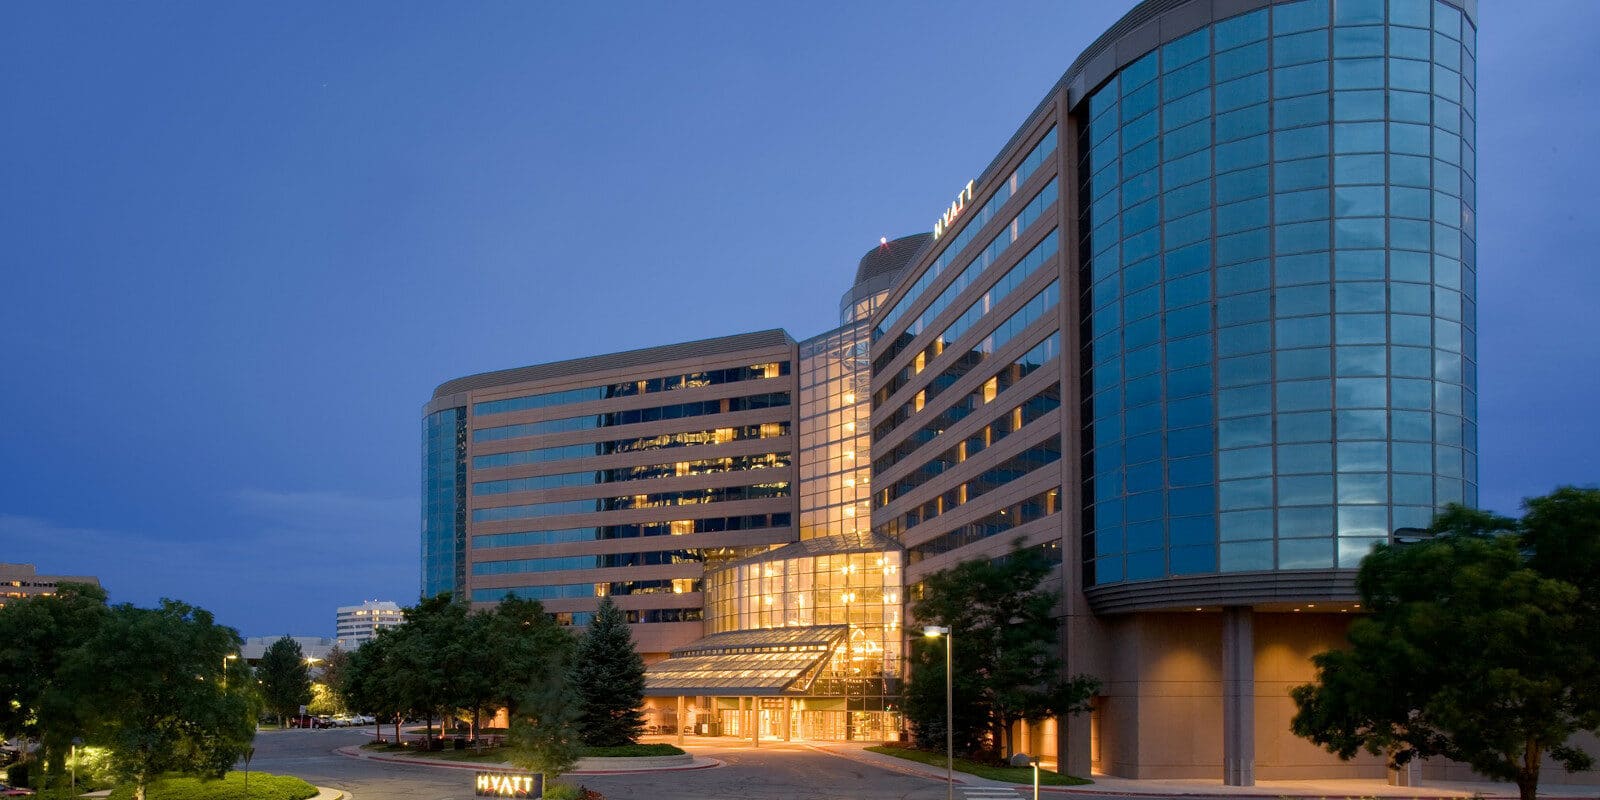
[0,0,1600,635]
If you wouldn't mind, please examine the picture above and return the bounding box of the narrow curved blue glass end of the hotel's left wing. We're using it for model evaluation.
[422,408,467,597]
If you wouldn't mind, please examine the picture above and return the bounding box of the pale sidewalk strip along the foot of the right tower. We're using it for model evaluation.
[810,742,1600,800]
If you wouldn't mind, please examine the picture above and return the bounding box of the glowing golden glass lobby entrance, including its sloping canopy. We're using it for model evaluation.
[645,533,902,742]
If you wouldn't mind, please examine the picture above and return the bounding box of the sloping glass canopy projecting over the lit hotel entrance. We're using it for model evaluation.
[645,626,850,698]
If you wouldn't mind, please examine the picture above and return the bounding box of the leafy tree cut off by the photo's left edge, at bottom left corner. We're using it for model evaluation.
[0,584,109,774]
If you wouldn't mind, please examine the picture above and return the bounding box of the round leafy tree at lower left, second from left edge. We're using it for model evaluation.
[61,600,261,800]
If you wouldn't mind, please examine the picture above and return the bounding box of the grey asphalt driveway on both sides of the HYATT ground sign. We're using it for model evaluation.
[250,728,963,800]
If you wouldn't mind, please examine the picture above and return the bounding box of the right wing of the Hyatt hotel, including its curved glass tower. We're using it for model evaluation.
[872,0,1477,784]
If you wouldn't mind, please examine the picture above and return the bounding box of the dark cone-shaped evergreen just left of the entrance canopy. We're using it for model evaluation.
[571,597,645,747]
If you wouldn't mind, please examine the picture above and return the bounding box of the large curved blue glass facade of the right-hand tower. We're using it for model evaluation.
[1078,0,1477,586]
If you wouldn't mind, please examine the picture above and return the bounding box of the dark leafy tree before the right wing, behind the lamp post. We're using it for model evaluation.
[906,541,1099,757]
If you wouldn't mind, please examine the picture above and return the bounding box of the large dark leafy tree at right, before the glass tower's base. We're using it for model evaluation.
[1291,488,1600,800]
